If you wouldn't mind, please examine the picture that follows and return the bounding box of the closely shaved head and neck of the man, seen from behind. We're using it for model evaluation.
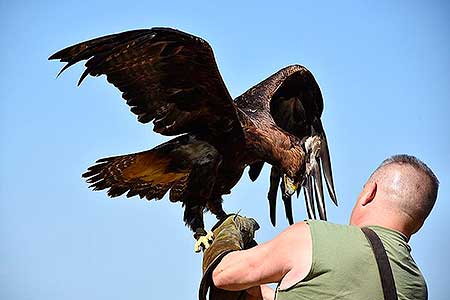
[351,154,439,235]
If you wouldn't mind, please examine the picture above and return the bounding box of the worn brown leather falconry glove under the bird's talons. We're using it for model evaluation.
[199,214,259,300]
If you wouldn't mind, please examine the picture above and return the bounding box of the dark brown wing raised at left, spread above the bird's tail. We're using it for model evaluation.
[49,28,242,135]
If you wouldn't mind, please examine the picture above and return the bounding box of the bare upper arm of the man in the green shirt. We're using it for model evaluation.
[213,222,312,291]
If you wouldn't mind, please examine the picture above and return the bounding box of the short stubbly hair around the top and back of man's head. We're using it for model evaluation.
[369,154,439,220]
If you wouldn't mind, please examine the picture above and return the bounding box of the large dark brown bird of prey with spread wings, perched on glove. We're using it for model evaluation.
[49,28,337,251]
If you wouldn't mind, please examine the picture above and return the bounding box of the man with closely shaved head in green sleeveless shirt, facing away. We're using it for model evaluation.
[212,155,439,300]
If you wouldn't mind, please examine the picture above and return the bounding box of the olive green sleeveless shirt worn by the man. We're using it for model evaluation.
[275,220,427,300]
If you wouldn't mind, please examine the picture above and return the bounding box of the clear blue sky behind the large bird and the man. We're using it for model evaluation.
[0,0,450,300]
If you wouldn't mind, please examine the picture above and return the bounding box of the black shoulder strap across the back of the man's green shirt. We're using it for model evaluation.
[361,227,397,300]
